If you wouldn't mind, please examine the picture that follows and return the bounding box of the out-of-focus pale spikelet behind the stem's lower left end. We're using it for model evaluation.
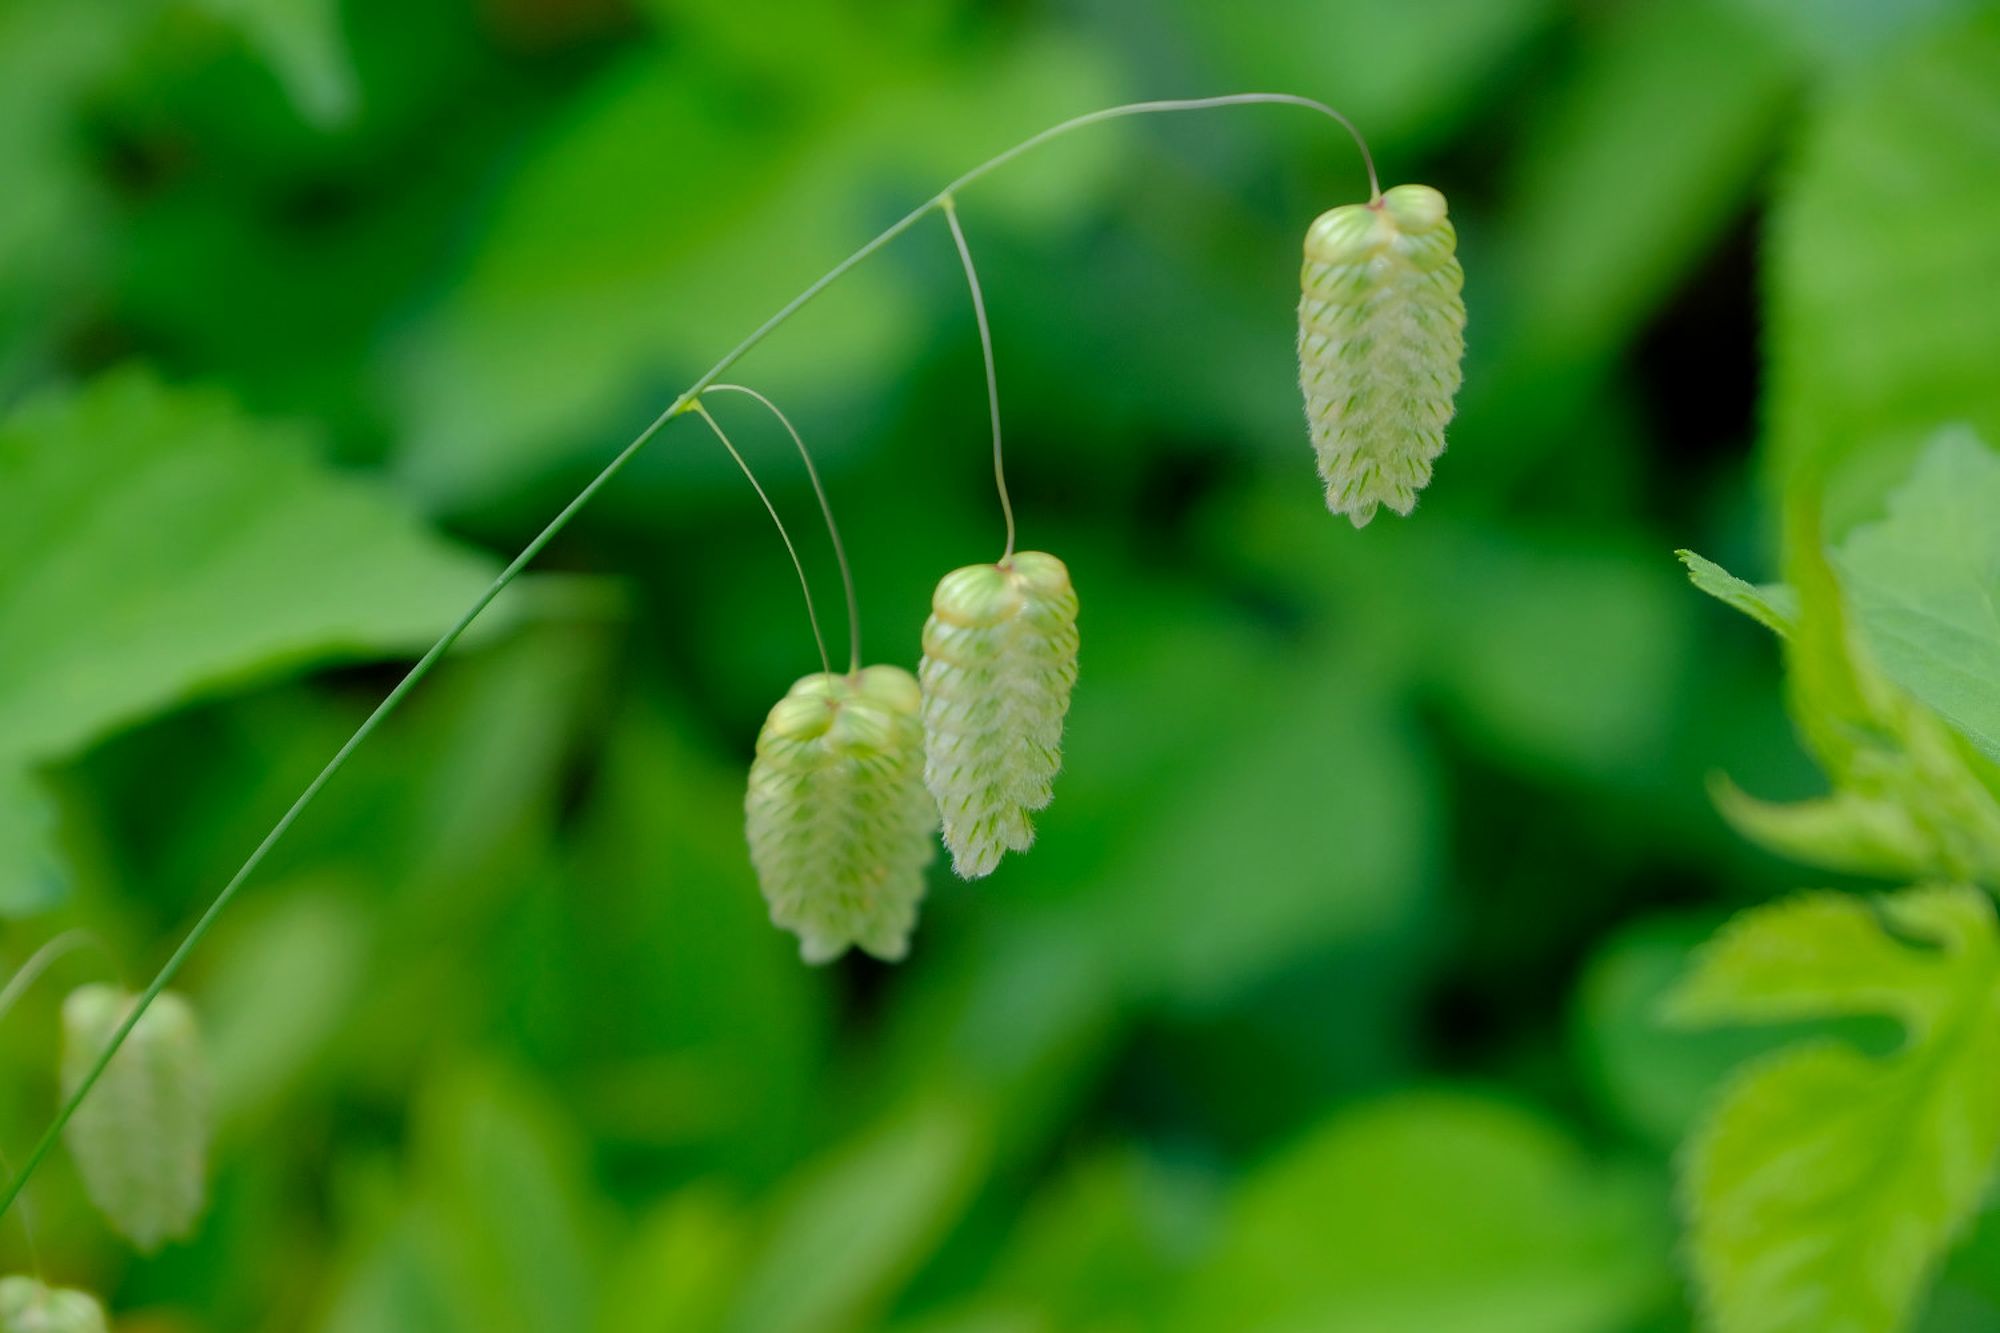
[62,987,210,1253]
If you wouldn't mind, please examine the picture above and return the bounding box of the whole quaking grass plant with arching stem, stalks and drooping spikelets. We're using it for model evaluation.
[0,92,1464,1296]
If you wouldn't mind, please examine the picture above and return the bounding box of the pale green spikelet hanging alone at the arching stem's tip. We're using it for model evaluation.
[1298,186,1466,528]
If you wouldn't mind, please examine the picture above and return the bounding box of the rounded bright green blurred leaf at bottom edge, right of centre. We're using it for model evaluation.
[1172,1091,1672,1333]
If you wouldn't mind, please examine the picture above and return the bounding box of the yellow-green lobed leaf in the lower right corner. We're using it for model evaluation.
[1664,887,2000,1333]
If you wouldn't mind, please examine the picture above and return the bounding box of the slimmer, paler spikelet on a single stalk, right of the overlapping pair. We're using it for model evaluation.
[920,550,1076,879]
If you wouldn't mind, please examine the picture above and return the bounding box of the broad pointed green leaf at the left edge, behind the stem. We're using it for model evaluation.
[0,372,490,913]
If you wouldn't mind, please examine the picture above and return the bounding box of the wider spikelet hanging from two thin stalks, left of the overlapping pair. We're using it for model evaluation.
[744,667,938,963]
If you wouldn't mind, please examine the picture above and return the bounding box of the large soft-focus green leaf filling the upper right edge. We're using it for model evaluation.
[1766,6,2000,538]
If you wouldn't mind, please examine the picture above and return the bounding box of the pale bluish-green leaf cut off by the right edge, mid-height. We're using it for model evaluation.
[1836,430,2000,761]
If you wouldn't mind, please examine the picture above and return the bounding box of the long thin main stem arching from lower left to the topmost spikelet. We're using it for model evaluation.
[0,92,1382,1213]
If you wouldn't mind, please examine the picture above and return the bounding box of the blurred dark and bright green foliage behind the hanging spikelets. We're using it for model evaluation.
[0,0,2000,1333]
